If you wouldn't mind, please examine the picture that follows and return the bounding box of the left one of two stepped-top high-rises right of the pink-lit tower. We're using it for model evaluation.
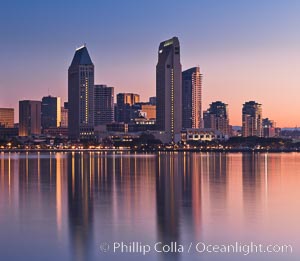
[203,101,231,136]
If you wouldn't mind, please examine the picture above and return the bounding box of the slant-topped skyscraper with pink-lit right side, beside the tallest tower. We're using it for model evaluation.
[182,67,202,128]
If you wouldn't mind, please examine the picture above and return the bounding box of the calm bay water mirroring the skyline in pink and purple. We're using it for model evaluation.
[0,152,300,261]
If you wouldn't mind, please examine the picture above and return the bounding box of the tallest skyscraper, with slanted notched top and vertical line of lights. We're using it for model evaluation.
[156,37,182,142]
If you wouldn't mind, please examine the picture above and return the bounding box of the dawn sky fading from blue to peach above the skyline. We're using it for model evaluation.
[0,0,300,127]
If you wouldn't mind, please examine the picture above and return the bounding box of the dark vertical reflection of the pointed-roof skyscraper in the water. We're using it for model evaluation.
[68,153,94,261]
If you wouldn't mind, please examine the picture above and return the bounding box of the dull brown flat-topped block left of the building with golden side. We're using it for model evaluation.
[19,100,41,136]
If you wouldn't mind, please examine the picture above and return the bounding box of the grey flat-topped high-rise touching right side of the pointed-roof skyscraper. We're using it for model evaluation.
[94,84,114,126]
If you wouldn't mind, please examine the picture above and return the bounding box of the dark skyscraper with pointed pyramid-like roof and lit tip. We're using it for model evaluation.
[68,46,94,140]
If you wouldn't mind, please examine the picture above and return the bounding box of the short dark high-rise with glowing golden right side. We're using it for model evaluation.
[42,96,61,129]
